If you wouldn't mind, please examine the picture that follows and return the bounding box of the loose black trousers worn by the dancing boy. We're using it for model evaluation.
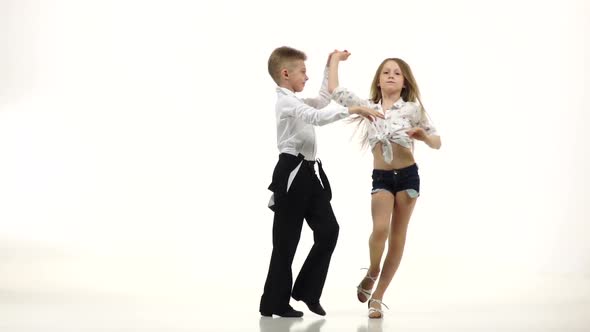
[260,154,339,312]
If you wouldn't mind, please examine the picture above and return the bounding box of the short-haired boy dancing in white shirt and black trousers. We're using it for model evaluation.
[259,47,383,317]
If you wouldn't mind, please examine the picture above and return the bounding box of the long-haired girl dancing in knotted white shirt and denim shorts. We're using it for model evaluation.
[328,51,441,318]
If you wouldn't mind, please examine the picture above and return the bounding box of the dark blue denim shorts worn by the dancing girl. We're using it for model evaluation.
[371,164,420,198]
